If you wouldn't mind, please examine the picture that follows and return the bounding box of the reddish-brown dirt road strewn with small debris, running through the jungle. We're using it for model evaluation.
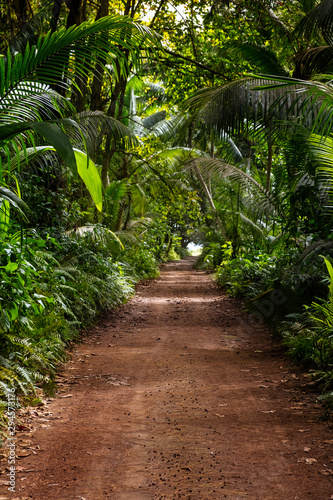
[0,259,333,500]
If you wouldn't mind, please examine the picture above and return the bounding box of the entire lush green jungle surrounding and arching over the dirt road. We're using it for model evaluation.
[0,0,333,437]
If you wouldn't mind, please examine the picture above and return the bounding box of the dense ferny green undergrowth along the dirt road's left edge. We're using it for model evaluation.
[0,228,159,442]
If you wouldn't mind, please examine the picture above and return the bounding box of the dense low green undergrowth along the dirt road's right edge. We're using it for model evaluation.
[199,243,333,407]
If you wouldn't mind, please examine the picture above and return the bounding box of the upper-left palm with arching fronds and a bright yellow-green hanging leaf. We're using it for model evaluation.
[0,16,157,221]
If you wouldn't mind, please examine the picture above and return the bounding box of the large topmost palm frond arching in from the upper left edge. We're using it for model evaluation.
[0,16,158,98]
